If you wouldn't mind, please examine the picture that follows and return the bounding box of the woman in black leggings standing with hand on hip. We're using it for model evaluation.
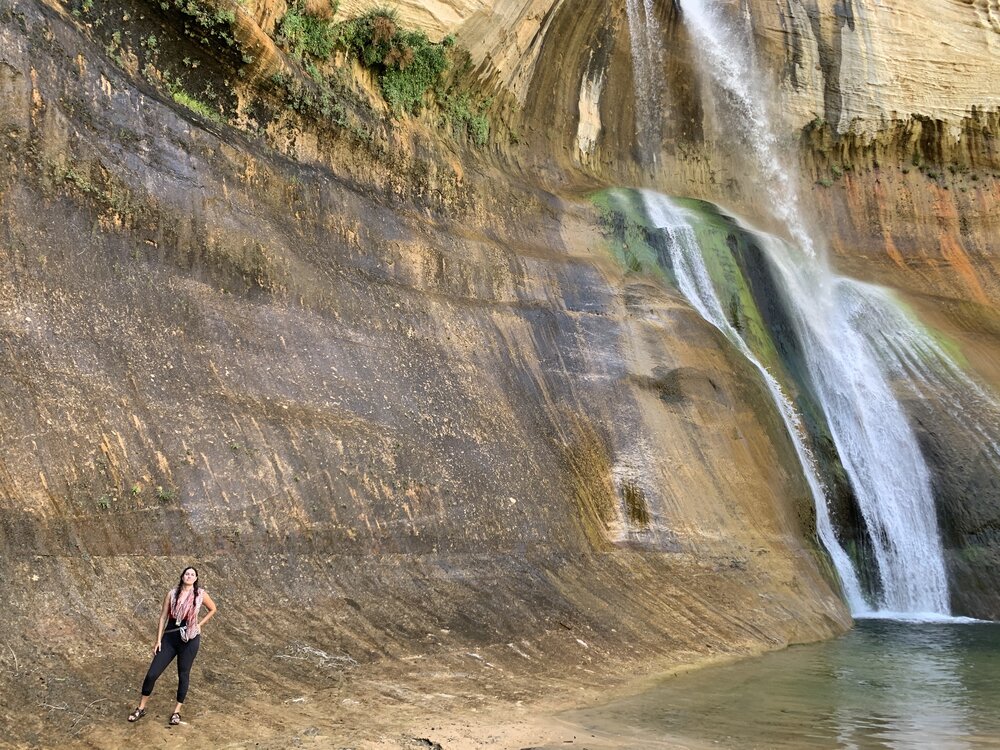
[128,568,217,724]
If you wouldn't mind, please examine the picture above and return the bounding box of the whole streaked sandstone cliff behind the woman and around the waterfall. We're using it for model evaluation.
[0,0,1000,747]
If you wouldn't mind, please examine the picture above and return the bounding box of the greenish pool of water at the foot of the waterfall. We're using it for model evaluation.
[562,620,1000,750]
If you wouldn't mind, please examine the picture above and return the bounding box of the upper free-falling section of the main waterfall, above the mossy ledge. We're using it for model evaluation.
[676,0,816,255]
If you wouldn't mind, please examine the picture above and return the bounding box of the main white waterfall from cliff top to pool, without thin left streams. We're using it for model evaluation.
[668,0,950,616]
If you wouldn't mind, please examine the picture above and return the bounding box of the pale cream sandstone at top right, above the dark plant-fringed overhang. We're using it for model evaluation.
[753,0,1000,134]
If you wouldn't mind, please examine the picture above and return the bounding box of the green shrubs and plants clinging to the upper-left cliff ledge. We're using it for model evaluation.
[66,0,491,146]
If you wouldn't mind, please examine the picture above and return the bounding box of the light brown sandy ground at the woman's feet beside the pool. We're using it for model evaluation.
[41,657,731,750]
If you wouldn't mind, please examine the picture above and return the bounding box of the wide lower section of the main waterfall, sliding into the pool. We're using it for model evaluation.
[758,235,950,615]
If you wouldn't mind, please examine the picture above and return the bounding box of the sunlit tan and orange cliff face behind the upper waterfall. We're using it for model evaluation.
[390,0,1000,286]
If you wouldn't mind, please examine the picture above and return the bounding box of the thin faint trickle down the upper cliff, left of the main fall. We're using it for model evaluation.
[625,0,663,164]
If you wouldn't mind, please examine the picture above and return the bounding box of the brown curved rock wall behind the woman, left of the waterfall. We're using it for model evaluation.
[0,3,848,747]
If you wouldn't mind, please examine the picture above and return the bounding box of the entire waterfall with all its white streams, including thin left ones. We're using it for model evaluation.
[626,0,968,618]
